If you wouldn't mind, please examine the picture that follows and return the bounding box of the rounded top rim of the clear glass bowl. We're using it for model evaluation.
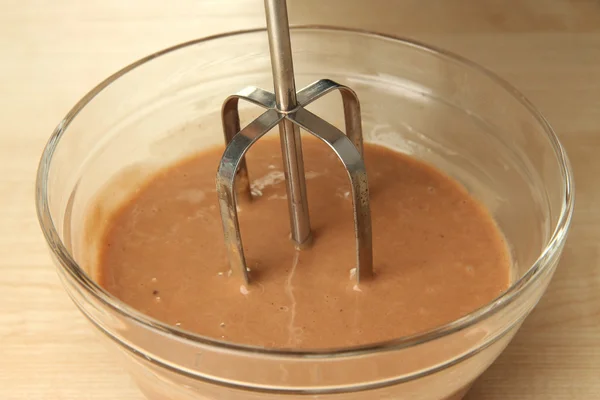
[35,25,574,359]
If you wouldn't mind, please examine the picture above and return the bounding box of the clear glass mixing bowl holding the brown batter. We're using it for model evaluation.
[36,27,573,400]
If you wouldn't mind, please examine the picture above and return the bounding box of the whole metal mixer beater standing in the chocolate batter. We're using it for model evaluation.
[217,0,373,284]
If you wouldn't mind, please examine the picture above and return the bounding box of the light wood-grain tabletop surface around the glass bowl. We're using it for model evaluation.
[0,0,600,400]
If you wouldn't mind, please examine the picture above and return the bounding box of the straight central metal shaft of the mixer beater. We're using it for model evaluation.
[265,0,311,246]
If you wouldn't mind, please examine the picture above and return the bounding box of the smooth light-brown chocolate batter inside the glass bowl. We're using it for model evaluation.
[99,138,510,349]
